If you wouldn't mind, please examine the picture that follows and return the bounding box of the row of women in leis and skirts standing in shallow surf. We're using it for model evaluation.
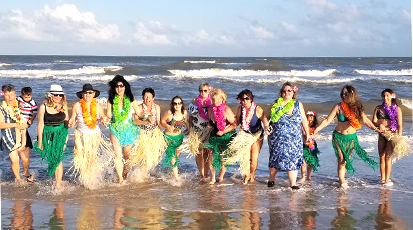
[0,75,408,189]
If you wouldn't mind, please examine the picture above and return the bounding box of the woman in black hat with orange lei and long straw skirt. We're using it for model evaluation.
[69,84,113,188]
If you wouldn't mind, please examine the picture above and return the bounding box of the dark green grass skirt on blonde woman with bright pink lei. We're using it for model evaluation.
[205,130,236,171]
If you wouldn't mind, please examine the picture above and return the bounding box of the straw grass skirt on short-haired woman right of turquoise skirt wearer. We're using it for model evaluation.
[126,127,168,170]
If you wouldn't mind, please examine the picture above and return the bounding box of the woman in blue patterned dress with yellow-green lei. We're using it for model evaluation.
[268,82,309,189]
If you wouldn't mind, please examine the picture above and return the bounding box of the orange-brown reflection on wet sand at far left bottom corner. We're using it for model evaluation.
[11,200,33,229]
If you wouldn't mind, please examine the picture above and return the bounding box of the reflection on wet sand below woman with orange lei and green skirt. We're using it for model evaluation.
[331,191,357,229]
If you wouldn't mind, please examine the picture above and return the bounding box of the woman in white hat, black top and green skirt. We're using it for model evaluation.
[34,85,69,189]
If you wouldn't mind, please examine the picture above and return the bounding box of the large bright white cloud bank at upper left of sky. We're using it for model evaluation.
[0,4,120,43]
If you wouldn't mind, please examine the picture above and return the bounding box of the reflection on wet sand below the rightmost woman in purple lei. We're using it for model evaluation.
[375,188,408,229]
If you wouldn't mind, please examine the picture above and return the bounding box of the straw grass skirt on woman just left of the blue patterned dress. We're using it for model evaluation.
[222,129,262,175]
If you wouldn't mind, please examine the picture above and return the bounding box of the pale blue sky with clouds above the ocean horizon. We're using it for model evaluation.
[0,0,412,57]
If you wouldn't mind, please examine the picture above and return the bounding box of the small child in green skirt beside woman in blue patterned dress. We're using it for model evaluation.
[300,111,320,181]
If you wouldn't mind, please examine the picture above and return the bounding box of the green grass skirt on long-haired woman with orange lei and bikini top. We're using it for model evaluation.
[332,131,378,174]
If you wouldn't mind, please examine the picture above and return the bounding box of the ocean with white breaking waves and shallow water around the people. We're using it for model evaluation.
[0,56,413,229]
